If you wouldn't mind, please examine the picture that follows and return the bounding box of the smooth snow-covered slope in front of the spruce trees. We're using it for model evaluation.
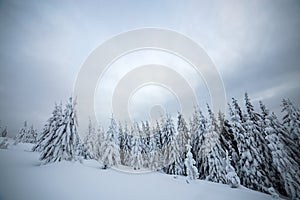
[0,138,272,200]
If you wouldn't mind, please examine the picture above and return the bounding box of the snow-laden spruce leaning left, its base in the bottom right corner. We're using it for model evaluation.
[260,102,300,199]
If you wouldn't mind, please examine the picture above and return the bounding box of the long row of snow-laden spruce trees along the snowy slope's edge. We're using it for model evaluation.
[9,93,300,199]
